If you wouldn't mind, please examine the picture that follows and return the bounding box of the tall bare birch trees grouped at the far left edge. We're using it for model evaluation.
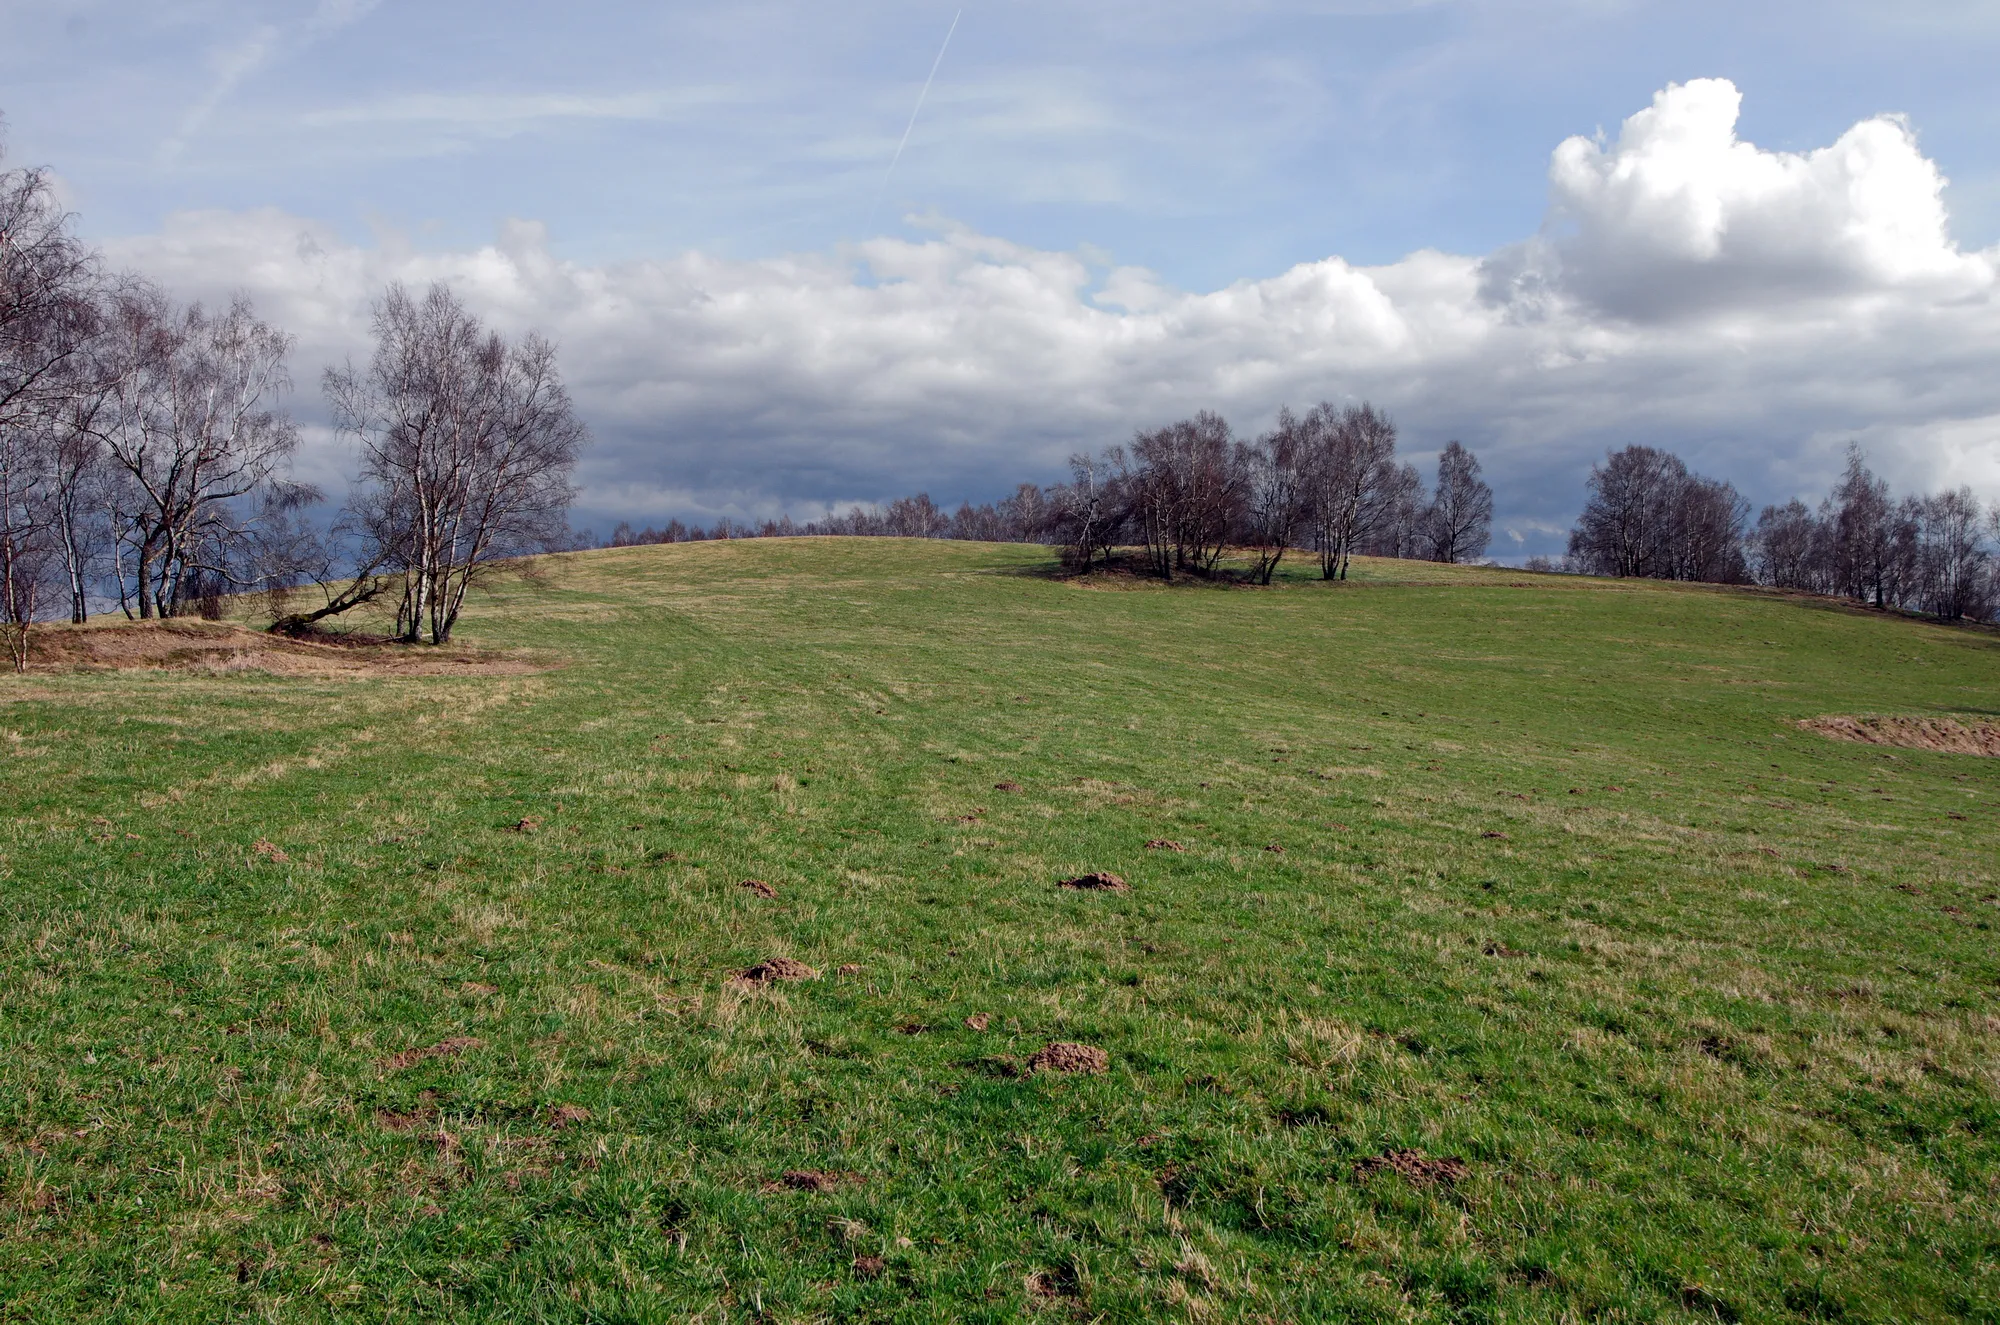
[0,143,588,669]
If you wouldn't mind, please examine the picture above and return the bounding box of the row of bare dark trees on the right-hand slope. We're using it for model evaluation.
[1552,446,2000,620]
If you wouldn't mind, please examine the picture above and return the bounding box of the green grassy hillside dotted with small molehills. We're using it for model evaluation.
[0,540,2000,1321]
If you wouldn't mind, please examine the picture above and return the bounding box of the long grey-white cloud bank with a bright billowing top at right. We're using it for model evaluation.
[101,80,2000,552]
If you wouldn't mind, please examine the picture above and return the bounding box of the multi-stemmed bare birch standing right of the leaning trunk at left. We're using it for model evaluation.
[324,284,588,644]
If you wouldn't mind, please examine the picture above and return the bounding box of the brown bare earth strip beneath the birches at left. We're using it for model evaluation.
[28,618,548,677]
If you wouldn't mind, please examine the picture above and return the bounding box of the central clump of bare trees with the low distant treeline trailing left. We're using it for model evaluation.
[610,402,1494,584]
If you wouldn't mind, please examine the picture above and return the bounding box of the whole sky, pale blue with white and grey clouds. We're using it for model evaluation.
[0,0,2000,558]
